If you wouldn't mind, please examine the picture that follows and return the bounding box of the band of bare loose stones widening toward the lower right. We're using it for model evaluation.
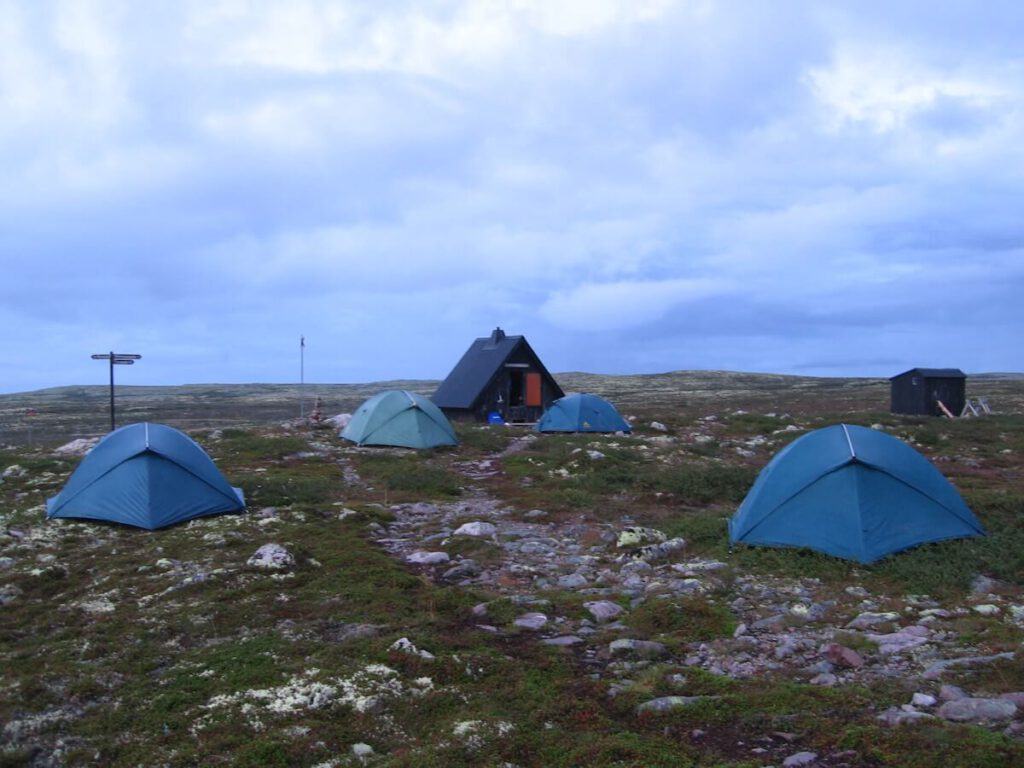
[375,437,1024,765]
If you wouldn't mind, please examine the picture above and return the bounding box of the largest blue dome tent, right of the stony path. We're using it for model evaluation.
[729,424,985,563]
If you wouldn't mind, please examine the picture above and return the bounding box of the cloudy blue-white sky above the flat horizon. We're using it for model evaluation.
[0,0,1024,392]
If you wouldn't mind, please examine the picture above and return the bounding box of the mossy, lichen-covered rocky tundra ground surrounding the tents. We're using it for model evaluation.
[0,373,1024,768]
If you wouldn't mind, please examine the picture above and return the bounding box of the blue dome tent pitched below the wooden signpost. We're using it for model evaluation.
[46,423,245,529]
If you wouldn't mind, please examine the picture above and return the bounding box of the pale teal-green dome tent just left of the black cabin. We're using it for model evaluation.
[341,389,459,449]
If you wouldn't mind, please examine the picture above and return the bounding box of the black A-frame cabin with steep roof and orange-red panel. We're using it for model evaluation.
[430,328,564,423]
